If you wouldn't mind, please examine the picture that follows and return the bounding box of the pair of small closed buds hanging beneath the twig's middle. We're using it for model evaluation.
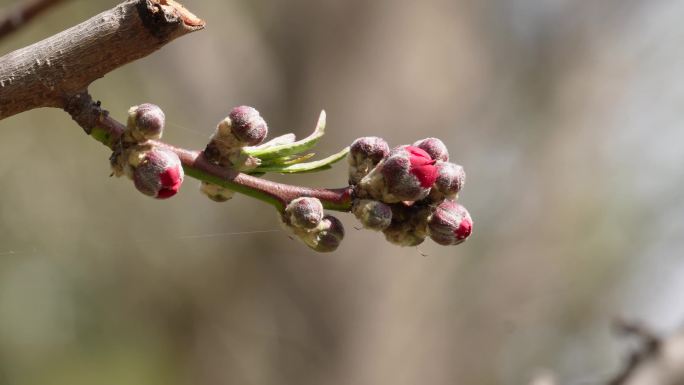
[280,197,344,253]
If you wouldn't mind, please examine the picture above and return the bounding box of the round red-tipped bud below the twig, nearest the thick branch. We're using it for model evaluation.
[133,148,183,199]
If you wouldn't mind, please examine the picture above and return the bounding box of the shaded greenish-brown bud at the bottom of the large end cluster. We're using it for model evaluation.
[383,204,430,246]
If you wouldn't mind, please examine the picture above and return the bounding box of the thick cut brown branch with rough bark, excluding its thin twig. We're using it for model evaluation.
[0,0,204,119]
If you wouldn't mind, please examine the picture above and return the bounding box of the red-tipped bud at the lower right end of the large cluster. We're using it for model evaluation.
[428,200,473,246]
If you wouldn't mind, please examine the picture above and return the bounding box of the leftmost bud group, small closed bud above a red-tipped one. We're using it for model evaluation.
[110,103,184,199]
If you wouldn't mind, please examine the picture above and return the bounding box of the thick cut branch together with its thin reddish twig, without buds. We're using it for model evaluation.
[0,0,352,211]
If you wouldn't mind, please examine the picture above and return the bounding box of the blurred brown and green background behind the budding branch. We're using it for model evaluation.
[0,0,684,385]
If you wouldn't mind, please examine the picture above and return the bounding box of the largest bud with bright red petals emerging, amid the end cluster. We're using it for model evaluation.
[359,146,437,203]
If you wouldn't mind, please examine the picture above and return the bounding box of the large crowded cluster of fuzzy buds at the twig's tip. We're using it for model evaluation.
[348,137,472,246]
